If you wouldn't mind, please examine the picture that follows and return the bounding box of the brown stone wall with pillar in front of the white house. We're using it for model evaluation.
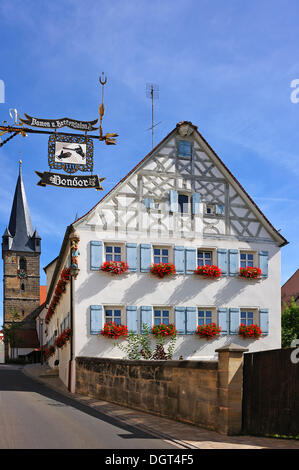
[76,345,248,434]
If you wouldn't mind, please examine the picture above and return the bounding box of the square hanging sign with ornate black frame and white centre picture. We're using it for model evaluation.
[48,134,93,173]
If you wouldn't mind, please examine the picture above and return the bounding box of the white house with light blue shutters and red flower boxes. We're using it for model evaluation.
[41,121,288,391]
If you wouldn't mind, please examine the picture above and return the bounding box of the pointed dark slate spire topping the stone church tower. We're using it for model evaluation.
[2,161,40,252]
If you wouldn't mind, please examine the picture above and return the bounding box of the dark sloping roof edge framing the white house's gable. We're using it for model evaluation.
[71,121,289,246]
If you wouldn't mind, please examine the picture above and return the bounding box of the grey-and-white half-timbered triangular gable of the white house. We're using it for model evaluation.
[73,122,287,244]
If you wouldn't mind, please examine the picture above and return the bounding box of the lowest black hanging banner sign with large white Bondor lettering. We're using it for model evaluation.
[35,171,106,191]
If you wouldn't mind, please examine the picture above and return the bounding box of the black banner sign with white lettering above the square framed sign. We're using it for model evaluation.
[20,113,98,132]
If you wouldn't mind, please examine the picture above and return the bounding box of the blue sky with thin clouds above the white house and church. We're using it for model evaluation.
[0,0,299,325]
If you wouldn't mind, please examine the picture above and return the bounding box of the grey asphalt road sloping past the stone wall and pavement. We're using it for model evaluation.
[0,365,177,449]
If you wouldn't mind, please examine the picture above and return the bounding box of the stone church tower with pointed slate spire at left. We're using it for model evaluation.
[2,161,41,325]
